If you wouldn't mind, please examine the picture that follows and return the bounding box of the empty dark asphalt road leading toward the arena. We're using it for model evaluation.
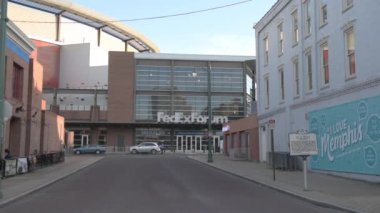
[0,155,341,213]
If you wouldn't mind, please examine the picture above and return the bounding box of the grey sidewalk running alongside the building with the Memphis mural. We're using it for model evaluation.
[188,155,380,213]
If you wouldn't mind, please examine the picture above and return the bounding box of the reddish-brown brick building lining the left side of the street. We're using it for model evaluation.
[1,21,65,157]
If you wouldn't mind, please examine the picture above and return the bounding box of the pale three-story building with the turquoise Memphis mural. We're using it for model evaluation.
[255,0,380,179]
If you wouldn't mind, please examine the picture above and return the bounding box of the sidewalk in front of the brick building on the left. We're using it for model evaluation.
[0,155,103,206]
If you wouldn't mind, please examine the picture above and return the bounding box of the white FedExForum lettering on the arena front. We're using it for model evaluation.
[157,112,228,124]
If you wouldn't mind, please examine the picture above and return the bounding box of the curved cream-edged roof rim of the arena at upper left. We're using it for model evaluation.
[9,0,159,52]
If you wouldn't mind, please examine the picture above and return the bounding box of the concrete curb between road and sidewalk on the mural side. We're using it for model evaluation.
[187,156,360,213]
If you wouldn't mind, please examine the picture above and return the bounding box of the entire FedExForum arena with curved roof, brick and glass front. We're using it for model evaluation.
[8,0,255,152]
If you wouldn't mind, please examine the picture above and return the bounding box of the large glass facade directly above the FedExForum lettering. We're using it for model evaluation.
[135,65,248,122]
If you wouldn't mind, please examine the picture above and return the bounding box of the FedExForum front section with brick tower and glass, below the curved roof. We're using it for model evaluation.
[45,50,254,152]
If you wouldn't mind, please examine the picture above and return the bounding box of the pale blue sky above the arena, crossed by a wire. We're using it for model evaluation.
[66,0,277,56]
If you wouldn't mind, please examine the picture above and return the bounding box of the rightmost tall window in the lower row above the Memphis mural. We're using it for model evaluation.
[345,27,356,78]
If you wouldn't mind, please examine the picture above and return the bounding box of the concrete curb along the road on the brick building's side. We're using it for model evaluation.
[0,158,104,207]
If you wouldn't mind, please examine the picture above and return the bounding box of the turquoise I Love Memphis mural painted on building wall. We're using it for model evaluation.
[309,96,380,175]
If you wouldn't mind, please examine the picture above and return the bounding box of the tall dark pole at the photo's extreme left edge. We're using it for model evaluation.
[0,0,8,198]
